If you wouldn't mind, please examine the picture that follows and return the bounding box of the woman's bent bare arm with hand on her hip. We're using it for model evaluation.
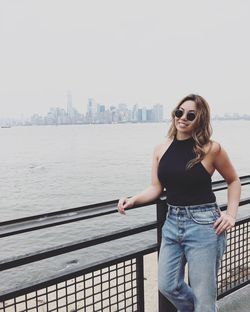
[214,143,241,234]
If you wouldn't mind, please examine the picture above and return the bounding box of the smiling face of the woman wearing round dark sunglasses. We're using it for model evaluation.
[175,101,197,137]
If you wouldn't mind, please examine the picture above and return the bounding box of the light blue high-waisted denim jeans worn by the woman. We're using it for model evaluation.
[158,203,226,312]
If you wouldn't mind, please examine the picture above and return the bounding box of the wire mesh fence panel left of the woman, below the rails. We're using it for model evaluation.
[0,258,139,312]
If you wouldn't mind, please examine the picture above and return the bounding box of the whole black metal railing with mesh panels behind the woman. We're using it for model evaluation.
[0,175,250,312]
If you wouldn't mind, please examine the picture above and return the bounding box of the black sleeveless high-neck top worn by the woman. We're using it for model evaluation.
[158,138,216,206]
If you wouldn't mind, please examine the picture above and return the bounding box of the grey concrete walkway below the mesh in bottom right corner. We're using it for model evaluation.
[218,285,250,312]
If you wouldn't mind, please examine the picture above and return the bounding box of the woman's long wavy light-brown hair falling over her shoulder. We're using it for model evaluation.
[168,94,212,169]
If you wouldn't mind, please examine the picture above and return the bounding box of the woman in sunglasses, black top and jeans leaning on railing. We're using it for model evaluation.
[118,94,241,312]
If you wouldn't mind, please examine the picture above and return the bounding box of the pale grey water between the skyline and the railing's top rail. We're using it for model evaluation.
[0,121,250,221]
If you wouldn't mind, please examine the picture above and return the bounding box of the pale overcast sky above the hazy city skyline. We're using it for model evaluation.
[0,0,250,117]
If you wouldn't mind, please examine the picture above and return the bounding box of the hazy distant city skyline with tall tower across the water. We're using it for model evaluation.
[0,92,250,127]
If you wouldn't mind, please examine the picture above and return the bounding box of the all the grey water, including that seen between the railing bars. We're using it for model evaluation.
[0,121,250,291]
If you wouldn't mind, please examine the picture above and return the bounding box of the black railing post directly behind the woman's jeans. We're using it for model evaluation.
[156,196,177,312]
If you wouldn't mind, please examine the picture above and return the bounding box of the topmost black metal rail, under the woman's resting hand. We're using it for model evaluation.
[0,175,250,238]
